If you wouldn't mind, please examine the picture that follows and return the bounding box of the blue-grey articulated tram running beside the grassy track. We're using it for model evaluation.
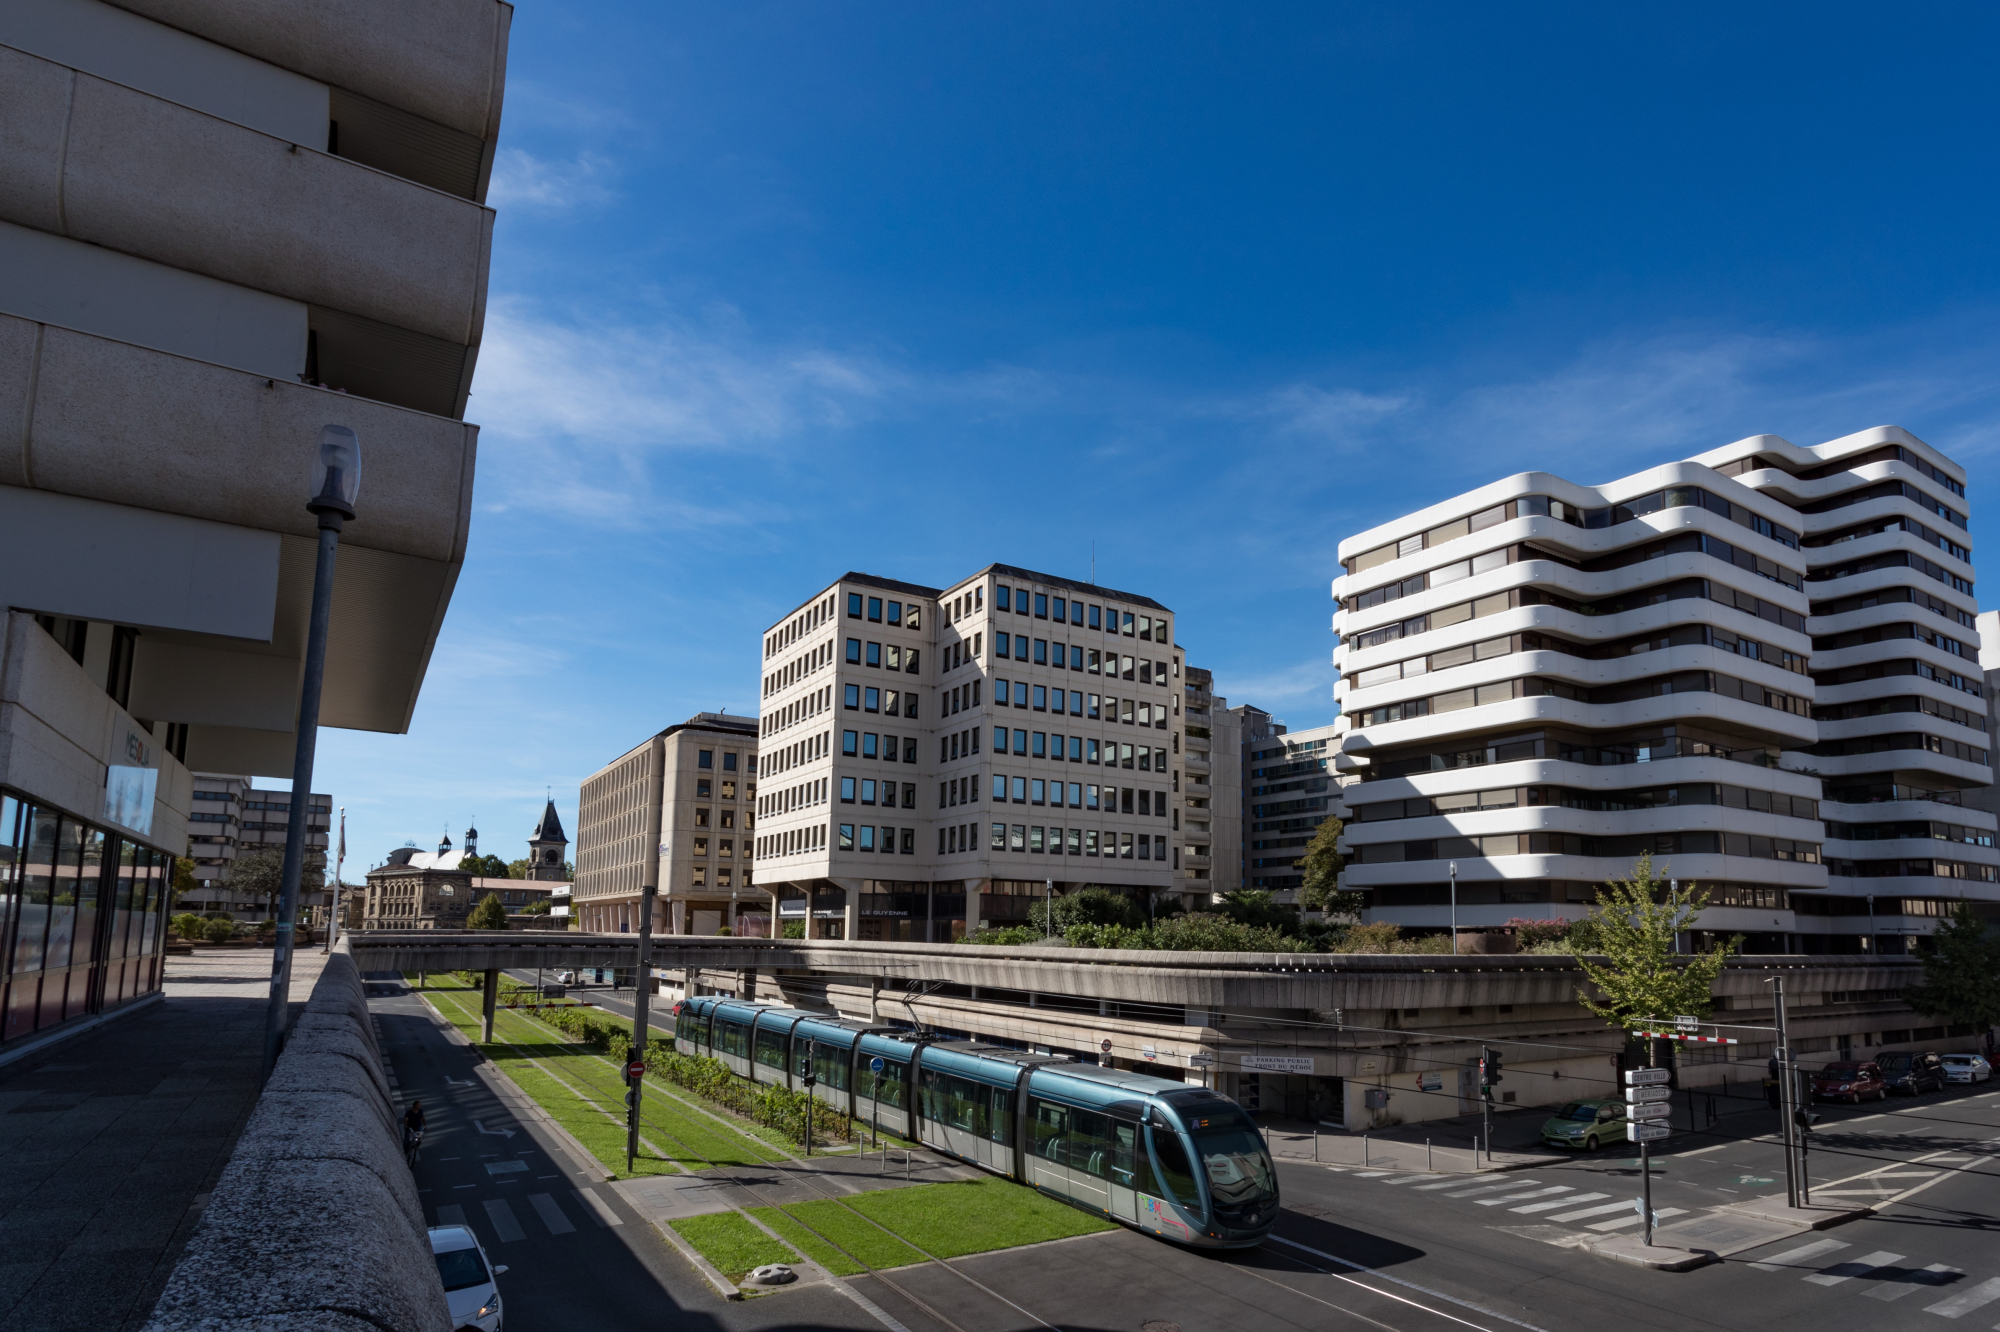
[674,996,1278,1248]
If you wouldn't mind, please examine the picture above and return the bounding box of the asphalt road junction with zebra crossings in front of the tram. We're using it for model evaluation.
[476,974,2000,1332]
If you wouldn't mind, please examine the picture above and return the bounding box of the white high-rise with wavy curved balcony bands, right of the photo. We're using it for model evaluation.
[1334,428,2000,952]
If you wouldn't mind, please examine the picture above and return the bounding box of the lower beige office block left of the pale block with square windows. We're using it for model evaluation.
[574,712,770,934]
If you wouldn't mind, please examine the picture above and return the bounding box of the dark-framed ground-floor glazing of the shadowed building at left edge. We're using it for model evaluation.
[0,790,174,1040]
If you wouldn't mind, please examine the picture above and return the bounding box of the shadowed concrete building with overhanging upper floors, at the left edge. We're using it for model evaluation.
[0,0,512,1042]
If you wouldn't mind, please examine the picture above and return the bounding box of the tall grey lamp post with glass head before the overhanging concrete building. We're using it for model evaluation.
[258,426,362,1084]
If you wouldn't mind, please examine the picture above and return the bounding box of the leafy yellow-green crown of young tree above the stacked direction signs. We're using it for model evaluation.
[1576,856,1736,1030]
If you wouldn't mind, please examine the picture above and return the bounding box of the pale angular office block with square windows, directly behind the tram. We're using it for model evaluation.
[754,564,1186,940]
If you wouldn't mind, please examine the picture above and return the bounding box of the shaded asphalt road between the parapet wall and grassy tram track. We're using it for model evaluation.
[368,976,882,1332]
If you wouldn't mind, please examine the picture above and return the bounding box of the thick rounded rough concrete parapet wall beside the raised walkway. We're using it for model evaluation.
[146,942,452,1332]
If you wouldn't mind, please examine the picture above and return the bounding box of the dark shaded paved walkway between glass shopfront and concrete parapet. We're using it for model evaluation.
[0,948,324,1332]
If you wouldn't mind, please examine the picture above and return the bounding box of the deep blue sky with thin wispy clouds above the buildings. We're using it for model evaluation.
[316,0,2000,868]
